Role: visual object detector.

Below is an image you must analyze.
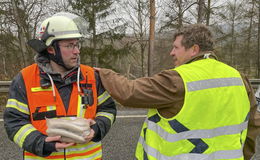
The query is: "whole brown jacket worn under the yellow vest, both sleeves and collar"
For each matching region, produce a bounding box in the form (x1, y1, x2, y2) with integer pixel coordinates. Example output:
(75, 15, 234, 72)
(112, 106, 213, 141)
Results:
(99, 54, 260, 160)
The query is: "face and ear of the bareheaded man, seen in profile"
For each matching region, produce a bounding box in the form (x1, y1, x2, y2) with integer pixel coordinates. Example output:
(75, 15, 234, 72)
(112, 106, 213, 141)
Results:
(170, 35, 193, 67)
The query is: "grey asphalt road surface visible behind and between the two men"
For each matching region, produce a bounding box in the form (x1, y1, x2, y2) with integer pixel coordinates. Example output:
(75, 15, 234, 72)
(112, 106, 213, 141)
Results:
(0, 112, 144, 160)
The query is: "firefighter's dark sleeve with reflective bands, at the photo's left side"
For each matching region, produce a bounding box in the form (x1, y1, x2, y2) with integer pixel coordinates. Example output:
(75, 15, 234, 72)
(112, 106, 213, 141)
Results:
(4, 73, 55, 157)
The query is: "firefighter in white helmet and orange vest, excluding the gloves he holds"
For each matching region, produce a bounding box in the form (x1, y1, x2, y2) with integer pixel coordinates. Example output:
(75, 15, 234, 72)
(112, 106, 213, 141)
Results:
(4, 12, 116, 160)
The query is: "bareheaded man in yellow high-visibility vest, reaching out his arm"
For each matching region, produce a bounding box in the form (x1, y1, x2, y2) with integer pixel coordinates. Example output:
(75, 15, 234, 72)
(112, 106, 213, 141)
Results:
(97, 24, 260, 160)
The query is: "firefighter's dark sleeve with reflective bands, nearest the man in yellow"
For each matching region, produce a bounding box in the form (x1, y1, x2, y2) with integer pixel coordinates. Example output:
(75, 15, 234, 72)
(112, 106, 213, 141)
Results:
(91, 72, 117, 142)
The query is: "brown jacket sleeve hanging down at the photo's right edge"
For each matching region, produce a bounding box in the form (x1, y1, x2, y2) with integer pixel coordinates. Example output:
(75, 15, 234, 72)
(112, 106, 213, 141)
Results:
(241, 74, 260, 160)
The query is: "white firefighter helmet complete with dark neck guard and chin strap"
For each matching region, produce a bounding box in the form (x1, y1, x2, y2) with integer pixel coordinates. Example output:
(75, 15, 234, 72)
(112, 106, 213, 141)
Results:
(27, 12, 87, 69)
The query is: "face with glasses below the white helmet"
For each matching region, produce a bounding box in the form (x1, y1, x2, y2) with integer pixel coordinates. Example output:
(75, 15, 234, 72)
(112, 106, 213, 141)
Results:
(59, 39, 80, 68)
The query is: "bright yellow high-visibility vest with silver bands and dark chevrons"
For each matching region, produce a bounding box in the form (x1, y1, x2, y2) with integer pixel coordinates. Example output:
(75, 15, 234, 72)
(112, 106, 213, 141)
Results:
(136, 59, 250, 160)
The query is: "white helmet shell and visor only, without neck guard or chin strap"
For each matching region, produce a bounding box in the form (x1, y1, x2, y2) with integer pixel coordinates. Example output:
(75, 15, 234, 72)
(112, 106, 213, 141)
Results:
(37, 12, 87, 46)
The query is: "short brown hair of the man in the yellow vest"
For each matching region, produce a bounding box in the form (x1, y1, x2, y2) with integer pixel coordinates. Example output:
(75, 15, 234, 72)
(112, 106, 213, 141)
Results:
(173, 24, 214, 51)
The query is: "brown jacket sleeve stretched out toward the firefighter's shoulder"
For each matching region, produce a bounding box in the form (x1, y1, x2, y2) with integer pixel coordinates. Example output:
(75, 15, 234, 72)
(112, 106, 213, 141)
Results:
(99, 69, 185, 109)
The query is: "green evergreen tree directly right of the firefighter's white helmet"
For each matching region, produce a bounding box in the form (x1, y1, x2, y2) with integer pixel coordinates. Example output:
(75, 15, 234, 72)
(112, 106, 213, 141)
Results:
(69, 0, 129, 69)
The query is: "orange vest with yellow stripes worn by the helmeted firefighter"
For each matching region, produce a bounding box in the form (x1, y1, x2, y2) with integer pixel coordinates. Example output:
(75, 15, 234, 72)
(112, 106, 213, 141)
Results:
(20, 64, 102, 160)
